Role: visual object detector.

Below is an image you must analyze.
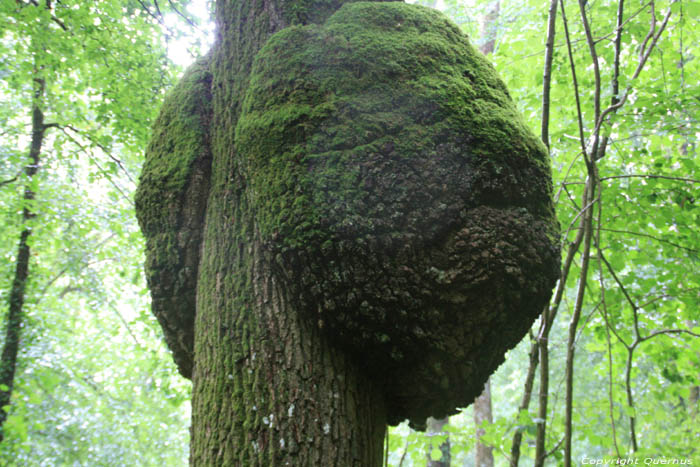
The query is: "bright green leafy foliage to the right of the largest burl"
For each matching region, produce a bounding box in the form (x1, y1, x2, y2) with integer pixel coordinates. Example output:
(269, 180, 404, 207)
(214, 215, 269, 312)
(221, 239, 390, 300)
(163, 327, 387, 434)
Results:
(392, 1, 700, 465)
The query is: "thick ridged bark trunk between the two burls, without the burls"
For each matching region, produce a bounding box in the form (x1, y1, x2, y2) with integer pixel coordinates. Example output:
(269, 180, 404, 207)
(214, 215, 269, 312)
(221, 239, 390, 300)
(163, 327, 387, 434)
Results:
(190, 0, 386, 467)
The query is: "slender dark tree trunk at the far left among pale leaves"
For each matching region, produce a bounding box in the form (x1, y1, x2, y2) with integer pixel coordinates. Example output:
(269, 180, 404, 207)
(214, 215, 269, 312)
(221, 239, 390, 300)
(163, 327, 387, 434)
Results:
(0, 78, 46, 442)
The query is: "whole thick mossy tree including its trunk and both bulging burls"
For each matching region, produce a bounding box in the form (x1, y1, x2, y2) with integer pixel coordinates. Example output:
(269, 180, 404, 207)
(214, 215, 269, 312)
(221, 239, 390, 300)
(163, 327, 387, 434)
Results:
(137, 0, 559, 466)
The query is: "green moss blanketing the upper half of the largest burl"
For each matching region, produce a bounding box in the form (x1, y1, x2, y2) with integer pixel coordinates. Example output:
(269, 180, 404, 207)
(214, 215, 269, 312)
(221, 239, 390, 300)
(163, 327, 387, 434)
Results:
(236, 3, 551, 252)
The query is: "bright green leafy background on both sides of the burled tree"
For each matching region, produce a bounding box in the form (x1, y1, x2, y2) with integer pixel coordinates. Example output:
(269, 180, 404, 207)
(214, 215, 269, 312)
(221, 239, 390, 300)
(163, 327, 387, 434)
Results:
(0, 0, 700, 466)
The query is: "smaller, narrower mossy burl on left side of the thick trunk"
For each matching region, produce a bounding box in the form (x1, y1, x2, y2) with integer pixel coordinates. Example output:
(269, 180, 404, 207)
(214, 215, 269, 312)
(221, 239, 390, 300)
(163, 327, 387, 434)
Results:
(135, 57, 211, 377)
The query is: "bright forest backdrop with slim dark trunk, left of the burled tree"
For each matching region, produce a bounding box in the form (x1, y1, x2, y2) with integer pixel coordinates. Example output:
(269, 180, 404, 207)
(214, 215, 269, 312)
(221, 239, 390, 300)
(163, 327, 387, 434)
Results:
(0, 0, 198, 465)
